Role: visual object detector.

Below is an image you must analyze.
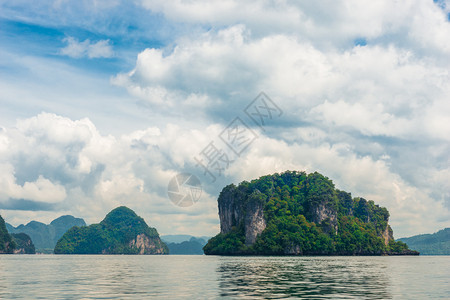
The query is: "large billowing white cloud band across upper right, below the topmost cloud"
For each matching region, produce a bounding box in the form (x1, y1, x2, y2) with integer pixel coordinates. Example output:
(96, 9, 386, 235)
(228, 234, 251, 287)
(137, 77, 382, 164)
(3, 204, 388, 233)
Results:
(113, 25, 450, 139)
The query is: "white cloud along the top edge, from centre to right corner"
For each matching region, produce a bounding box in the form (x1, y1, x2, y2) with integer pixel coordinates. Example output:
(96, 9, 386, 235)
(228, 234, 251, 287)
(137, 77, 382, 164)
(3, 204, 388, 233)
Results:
(141, 0, 450, 53)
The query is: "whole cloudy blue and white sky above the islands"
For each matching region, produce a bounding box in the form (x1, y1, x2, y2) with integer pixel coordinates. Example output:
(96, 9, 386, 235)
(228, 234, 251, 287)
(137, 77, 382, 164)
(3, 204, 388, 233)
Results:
(0, 0, 450, 238)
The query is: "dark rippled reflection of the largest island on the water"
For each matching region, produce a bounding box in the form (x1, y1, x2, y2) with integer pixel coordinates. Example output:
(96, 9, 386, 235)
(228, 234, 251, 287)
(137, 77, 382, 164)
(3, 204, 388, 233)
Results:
(217, 257, 392, 299)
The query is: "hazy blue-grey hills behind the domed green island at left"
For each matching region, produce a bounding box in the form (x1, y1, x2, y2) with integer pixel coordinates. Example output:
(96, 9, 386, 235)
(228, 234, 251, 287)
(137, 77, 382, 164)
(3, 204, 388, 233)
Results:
(6, 215, 86, 253)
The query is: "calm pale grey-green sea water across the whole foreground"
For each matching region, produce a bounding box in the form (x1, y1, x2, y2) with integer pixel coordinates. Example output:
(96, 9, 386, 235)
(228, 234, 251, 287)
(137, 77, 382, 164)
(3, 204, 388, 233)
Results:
(0, 255, 450, 299)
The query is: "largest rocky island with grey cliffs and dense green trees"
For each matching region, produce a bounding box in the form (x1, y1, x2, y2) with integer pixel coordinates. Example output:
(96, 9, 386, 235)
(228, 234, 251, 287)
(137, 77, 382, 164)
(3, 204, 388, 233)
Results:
(203, 171, 419, 255)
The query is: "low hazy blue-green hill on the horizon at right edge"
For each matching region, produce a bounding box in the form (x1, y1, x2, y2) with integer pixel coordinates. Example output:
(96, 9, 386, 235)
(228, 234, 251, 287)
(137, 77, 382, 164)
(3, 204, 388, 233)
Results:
(398, 228, 450, 255)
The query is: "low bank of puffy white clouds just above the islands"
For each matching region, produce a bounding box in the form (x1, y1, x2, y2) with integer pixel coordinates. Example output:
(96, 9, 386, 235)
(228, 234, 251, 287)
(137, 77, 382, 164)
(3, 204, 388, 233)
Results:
(0, 113, 449, 236)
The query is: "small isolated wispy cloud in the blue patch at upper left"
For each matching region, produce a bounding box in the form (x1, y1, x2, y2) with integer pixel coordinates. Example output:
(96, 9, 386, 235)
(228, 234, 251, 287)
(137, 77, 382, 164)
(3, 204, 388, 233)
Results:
(60, 36, 114, 58)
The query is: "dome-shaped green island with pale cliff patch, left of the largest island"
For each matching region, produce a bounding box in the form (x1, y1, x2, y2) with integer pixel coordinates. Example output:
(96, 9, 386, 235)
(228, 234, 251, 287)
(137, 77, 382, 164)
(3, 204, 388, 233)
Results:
(54, 206, 169, 254)
